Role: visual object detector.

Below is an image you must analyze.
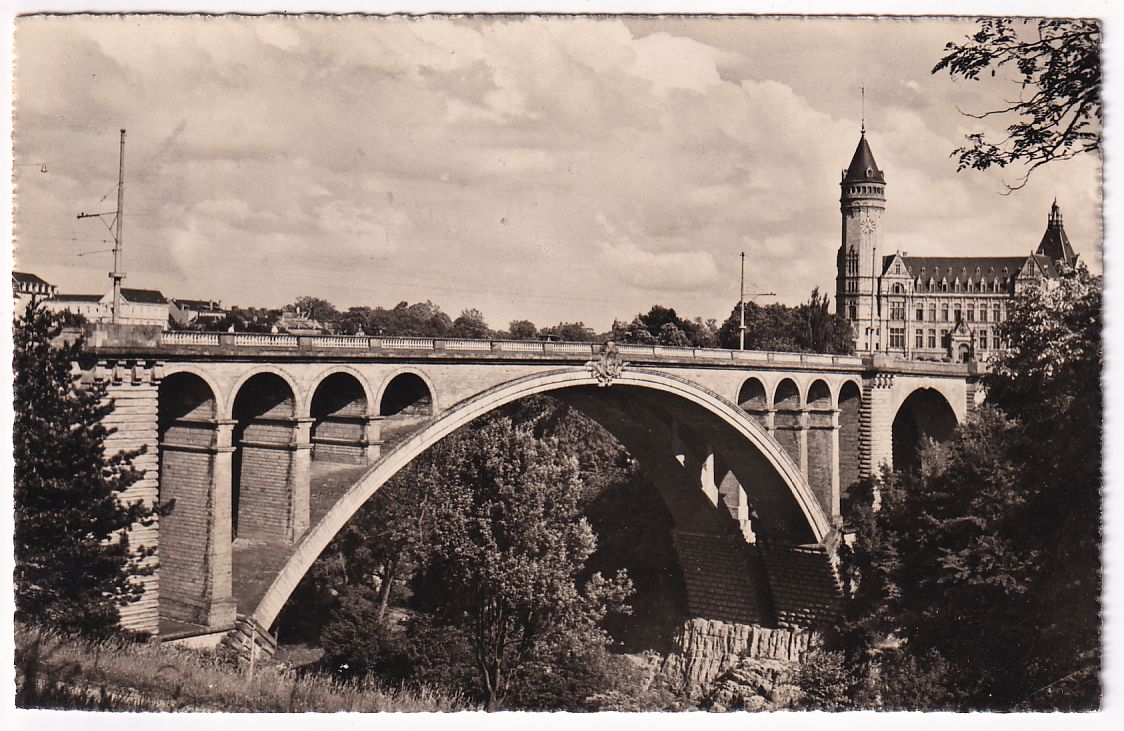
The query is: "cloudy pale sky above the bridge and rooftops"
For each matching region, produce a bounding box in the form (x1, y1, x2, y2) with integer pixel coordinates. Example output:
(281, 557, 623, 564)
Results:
(6, 16, 1102, 331)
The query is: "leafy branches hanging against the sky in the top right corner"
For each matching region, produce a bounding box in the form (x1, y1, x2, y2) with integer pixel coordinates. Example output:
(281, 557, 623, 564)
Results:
(933, 18, 1102, 192)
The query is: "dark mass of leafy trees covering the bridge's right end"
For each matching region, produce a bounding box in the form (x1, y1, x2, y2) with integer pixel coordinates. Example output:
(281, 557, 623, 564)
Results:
(836, 268, 1103, 710)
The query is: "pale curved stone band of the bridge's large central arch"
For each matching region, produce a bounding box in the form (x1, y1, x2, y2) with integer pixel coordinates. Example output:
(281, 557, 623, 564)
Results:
(252, 368, 832, 628)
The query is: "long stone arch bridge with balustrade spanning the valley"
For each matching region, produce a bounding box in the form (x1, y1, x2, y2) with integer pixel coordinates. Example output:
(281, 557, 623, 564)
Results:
(79, 327, 981, 637)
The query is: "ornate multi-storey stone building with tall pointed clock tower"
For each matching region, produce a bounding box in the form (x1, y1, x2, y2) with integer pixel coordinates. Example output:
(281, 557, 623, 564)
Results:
(835, 133, 1077, 361)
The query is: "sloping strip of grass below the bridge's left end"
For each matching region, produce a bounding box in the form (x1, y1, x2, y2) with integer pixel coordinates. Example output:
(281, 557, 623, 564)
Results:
(16, 624, 475, 713)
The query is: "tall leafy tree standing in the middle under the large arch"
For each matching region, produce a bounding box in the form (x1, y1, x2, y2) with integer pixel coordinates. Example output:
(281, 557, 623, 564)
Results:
(428, 421, 631, 709)
